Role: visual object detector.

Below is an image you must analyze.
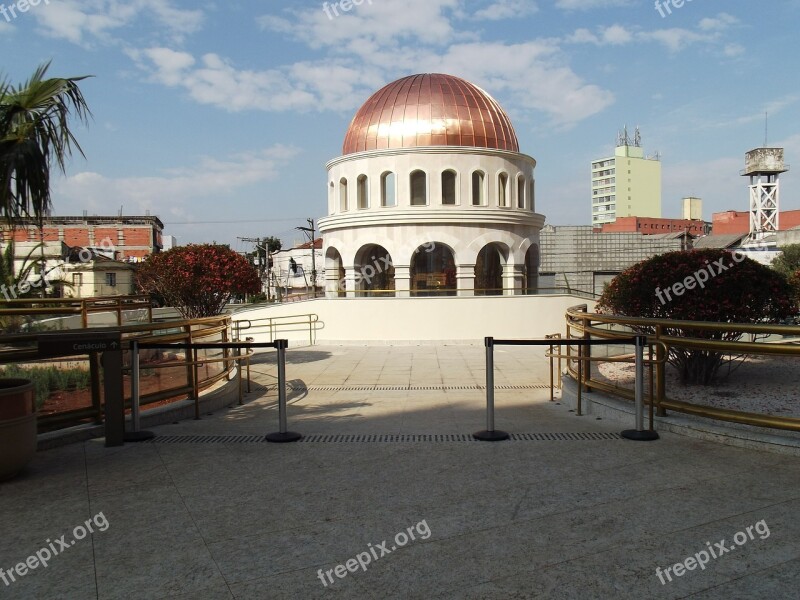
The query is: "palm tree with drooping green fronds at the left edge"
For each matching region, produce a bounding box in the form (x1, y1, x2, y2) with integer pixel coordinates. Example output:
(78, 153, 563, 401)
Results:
(0, 61, 91, 223)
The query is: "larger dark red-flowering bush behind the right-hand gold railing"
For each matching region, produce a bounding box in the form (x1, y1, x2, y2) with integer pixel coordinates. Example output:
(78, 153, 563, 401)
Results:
(597, 249, 797, 385)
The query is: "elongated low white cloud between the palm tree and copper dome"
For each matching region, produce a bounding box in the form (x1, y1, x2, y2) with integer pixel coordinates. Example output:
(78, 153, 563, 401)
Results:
(54, 145, 299, 216)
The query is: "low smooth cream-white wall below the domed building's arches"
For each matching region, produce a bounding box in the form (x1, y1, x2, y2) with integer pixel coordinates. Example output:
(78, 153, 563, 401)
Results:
(233, 295, 594, 344)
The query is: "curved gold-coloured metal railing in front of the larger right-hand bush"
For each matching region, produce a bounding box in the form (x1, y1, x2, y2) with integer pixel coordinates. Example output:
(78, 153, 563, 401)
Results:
(564, 304, 800, 431)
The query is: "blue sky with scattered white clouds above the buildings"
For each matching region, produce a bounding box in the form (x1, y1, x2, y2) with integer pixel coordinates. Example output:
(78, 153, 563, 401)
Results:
(0, 0, 800, 250)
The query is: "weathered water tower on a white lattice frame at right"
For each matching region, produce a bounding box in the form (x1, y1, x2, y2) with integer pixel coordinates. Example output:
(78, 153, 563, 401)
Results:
(741, 148, 789, 243)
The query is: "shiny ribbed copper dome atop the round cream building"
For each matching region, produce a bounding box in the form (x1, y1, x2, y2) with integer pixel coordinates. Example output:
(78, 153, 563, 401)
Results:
(342, 73, 519, 154)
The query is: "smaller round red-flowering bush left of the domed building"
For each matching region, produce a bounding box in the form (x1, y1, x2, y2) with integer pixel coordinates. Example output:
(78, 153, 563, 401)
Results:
(136, 244, 261, 319)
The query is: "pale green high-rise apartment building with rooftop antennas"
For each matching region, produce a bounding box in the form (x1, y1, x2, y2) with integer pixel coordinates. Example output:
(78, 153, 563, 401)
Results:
(592, 127, 661, 225)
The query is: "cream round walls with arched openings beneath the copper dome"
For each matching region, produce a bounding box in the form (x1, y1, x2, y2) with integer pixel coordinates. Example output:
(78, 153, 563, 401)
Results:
(319, 147, 544, 297)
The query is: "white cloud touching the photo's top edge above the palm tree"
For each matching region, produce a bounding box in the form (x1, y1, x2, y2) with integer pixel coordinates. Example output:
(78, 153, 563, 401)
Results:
(31, 0, 203, 45)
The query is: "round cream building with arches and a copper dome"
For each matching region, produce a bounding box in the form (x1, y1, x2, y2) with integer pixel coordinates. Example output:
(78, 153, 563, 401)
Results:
(319, 73, 544, 298)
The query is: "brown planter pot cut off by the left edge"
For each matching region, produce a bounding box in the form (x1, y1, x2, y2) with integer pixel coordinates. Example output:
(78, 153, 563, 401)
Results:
(0, 379, 36, 481)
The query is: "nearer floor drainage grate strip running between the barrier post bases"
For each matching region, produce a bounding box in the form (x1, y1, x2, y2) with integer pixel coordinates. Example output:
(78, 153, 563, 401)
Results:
(146, 431, 622, 444)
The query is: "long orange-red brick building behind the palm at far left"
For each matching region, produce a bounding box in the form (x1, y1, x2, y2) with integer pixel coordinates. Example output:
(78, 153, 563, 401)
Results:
(2, 216, 164, 262)
